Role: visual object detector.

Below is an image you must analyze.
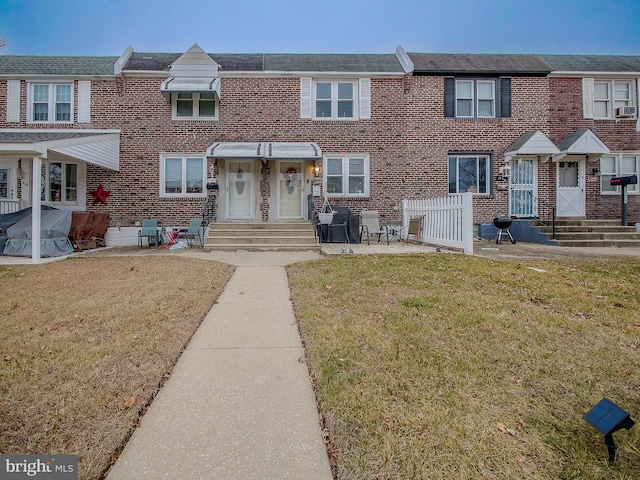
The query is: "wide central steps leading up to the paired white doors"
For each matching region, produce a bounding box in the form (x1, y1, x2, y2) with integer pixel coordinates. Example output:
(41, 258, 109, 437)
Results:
(205, 221, 320, 252)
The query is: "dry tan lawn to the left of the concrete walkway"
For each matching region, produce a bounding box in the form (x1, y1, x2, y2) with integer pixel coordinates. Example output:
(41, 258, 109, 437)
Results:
(0, 256, 233, 479)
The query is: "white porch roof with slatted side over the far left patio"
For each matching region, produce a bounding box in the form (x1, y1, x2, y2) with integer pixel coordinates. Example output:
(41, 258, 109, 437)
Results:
(0, 128, 120, 171)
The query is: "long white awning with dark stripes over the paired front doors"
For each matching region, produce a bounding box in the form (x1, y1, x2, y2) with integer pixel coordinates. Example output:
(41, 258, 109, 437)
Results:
(207, 142, 322, 160)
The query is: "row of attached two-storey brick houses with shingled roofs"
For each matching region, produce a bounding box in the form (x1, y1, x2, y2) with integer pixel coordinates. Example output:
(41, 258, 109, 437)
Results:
(0, 45, 640, 255)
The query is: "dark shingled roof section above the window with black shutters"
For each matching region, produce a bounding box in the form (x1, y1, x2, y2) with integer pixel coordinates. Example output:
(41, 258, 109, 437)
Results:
(408, 53, 551, 76)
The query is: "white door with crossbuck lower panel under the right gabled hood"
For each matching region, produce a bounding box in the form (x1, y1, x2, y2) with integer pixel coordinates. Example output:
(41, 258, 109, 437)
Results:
(556, 159, 585, 217)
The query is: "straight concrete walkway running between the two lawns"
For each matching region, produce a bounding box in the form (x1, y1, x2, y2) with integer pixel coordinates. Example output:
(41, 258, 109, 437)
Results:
(107, 252, 333, 480)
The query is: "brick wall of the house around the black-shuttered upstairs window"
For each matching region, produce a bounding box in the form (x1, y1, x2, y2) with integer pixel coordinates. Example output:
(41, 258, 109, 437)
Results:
(404, 76, 549, 223)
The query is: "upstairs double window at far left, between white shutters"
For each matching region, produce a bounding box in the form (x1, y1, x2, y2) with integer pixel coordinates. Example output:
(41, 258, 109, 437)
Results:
(28, 83, 73, 123)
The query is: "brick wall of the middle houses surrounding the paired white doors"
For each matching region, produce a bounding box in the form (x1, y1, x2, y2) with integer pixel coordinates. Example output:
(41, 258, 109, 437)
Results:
(88, 77, 405, 226)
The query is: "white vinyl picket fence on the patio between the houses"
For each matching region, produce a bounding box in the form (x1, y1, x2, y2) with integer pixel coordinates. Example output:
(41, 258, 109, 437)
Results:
(402, 193, 473, 255)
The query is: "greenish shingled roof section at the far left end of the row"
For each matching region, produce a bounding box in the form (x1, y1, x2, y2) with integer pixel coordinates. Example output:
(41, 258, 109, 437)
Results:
(0, 55, 118, 75)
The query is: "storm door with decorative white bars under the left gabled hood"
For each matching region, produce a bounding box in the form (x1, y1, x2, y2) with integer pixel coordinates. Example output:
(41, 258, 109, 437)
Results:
(509, 158, 538, 218)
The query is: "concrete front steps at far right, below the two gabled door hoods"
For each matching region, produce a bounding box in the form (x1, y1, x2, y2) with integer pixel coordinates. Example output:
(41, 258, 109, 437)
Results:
(538, 218, 640, 248)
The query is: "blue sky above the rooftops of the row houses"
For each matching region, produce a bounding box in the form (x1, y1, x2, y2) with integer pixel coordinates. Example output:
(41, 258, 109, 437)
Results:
(0, 0, 640, 56)
